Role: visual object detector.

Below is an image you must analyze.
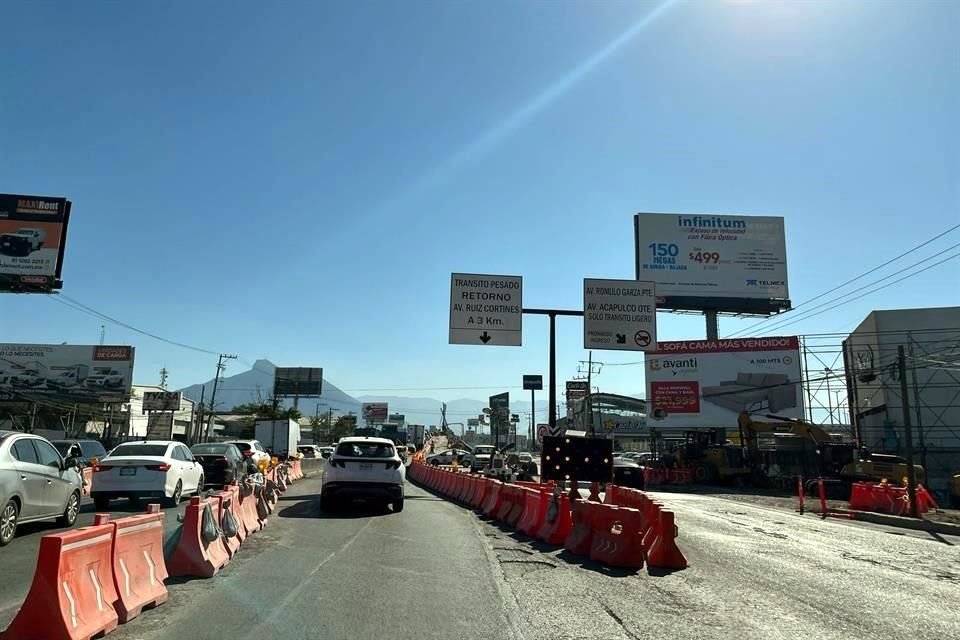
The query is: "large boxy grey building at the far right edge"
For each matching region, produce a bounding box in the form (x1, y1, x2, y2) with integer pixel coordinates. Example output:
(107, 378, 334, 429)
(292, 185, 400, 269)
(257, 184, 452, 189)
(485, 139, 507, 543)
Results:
(843, 307, 960, 491)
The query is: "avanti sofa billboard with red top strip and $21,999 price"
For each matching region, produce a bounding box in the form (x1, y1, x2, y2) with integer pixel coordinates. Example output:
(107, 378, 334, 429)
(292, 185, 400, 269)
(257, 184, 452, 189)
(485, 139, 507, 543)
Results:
(644, 336, 803, 429)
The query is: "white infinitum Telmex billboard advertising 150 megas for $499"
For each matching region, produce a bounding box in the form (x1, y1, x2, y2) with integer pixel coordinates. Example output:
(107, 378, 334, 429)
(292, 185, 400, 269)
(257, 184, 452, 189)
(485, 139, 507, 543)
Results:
(634, 213, 790, 314)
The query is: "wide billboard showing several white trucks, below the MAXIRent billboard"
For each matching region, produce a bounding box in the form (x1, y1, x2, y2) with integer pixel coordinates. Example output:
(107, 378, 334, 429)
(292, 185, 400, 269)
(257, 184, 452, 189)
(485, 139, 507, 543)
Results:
(0, 344, 133, 403)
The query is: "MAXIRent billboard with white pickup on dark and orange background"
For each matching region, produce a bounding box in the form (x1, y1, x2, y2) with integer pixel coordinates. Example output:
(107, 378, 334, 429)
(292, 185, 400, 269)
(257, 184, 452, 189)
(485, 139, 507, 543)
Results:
(0, 193, 71, 293)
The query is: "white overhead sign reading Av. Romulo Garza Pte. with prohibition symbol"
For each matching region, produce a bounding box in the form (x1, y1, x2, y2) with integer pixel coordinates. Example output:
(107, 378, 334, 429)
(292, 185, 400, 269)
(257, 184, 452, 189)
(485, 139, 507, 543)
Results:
(583, 278, 657, 351)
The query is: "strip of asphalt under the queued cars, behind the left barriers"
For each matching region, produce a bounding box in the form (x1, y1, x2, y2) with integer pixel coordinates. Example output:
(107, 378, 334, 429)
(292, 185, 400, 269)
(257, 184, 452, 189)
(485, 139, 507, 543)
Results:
(0, 498, 187, 629)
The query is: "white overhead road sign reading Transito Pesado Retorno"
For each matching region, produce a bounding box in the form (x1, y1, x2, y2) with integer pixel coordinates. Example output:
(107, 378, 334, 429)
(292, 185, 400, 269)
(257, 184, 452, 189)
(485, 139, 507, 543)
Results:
(450, 273, 523, 347)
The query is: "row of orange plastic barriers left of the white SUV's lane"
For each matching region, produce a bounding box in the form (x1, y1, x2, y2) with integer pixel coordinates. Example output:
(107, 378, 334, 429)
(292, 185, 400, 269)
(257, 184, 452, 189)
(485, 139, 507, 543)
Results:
(0, 460, 304, 640)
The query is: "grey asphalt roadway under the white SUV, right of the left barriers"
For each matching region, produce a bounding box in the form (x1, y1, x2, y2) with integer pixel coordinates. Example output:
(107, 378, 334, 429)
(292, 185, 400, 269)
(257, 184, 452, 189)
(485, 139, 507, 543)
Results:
(0, 464, 960, 640)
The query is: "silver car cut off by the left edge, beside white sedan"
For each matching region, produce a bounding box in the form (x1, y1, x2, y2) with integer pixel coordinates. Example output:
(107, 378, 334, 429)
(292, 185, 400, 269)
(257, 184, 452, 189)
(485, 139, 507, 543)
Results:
(0, 431, 82, 547)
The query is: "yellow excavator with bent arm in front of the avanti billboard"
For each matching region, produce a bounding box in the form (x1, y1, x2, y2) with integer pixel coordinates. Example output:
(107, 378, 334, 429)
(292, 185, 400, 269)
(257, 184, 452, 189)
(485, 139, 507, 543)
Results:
(737, 412, 926, 485)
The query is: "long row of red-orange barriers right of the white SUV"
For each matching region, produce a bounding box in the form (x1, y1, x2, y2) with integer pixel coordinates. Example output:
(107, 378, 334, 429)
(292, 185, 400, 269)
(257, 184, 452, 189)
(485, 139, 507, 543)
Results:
(407, 462, 687, 569)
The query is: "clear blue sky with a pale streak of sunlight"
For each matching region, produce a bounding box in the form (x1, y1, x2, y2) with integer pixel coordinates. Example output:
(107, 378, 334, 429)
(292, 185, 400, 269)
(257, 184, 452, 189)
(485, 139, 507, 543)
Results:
(0, 1, 960, 416)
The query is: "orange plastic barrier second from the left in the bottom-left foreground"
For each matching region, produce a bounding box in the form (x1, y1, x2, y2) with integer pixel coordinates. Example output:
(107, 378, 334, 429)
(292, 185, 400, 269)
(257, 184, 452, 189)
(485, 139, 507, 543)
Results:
(110, 504, 167, 622)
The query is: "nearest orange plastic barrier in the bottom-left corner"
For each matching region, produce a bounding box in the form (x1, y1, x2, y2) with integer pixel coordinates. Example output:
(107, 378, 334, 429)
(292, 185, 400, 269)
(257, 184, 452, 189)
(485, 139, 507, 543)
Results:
(0, 515, 119, 640)
